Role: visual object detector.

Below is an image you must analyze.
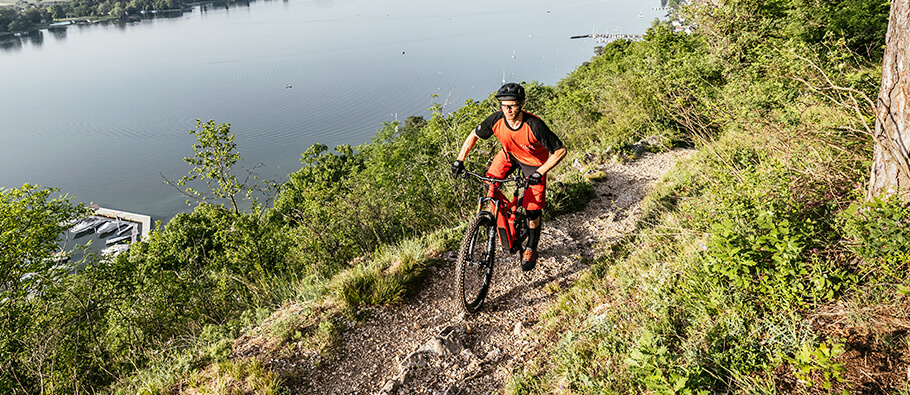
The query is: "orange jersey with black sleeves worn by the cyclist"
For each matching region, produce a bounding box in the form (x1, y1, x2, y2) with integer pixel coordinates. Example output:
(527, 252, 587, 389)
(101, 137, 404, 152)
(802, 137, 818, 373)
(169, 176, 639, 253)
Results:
(474, 111, 562, 167)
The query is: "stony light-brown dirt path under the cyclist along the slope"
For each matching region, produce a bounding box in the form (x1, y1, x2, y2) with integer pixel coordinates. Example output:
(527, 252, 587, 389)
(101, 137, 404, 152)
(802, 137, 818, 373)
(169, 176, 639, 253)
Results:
(290, 150, 693, 395)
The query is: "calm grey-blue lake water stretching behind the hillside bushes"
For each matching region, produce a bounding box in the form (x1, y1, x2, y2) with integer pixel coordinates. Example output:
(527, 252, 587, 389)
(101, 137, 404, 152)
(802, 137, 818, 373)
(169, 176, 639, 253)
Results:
(0, 0, 664, 221)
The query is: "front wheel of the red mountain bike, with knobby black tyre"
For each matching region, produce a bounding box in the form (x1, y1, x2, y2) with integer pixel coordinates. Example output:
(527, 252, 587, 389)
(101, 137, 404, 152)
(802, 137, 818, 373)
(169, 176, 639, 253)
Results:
(455, 213, 496, 314)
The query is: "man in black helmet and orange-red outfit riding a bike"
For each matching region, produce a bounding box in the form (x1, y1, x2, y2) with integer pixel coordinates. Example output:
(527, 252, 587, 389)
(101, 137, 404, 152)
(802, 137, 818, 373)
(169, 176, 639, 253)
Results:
(452, 82, 566, 271)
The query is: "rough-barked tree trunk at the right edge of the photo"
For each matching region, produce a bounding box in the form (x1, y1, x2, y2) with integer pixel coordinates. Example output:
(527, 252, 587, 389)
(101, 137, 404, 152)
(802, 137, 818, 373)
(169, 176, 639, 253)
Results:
(866, 0, 910, 202)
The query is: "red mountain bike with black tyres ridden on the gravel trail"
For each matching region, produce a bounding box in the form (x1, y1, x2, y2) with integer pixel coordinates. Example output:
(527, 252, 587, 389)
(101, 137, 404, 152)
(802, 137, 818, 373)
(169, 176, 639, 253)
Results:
(455, 171, 528, 314)
